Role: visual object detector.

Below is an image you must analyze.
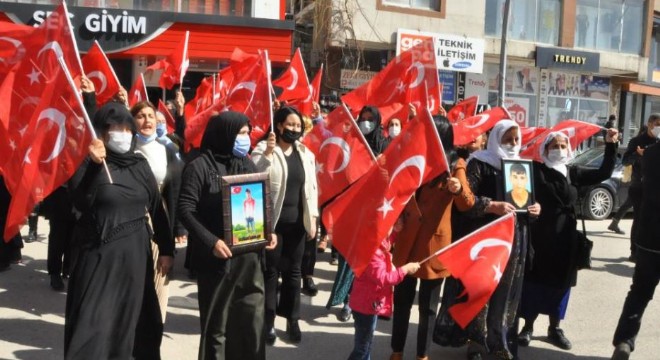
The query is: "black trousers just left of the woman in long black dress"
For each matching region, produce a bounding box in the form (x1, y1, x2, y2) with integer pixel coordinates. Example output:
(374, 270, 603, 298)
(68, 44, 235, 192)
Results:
(48, 219, 76, 275)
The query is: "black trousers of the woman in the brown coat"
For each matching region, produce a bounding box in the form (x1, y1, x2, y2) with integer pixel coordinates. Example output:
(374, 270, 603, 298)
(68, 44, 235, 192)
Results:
(391, 276, 444, 357)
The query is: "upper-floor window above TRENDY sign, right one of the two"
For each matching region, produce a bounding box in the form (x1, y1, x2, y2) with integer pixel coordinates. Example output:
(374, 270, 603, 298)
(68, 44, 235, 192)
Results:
(575, 0, 644, 54)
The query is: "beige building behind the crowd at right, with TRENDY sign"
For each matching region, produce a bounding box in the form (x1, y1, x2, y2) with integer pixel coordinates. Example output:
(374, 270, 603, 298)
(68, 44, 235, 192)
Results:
(314, 0, 660, 145)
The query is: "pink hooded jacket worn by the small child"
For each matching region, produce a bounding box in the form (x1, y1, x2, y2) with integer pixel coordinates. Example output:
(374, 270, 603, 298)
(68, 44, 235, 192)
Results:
(349, 240, 406, 317)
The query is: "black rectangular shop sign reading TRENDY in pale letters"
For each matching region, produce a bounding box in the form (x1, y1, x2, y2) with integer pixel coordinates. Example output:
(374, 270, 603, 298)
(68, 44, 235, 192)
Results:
(536, 47, 600, 72)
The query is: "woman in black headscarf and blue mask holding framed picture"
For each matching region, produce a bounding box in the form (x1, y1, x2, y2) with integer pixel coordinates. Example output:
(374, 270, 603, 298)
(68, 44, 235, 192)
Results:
(178, 111, 277, 360)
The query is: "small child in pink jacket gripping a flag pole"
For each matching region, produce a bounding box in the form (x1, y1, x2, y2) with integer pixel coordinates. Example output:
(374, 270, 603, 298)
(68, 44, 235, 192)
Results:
(348, 238, 419, 360)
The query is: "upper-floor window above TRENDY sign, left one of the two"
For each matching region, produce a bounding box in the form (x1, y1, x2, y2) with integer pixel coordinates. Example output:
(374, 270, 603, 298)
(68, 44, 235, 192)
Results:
(485, 0, 561, 45)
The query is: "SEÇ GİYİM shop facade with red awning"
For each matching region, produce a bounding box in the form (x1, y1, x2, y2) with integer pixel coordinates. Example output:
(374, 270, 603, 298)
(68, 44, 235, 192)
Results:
(0, 0, 294, 98)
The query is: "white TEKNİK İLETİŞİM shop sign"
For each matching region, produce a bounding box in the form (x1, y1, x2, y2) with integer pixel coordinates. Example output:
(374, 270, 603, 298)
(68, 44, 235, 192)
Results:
(396, 29, 485, 73)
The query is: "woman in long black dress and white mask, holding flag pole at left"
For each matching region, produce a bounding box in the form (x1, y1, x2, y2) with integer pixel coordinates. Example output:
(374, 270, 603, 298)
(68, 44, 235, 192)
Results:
(64, 102, 174, 359)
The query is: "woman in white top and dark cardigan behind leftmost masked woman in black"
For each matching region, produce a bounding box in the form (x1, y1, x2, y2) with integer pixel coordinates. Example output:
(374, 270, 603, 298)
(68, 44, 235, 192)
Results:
(131, 101, 188, 322)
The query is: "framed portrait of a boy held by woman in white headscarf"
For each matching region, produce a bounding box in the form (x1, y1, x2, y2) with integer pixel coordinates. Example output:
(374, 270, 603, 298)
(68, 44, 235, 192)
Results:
(502, 159, 534, 212)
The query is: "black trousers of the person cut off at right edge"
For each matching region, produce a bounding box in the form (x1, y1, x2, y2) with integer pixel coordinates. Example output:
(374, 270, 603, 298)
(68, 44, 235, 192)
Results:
(612, 249, 660, 350)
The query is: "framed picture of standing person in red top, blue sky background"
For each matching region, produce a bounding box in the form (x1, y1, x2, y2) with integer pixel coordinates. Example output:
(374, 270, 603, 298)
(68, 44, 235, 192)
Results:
(222, 173, 272, 254)
